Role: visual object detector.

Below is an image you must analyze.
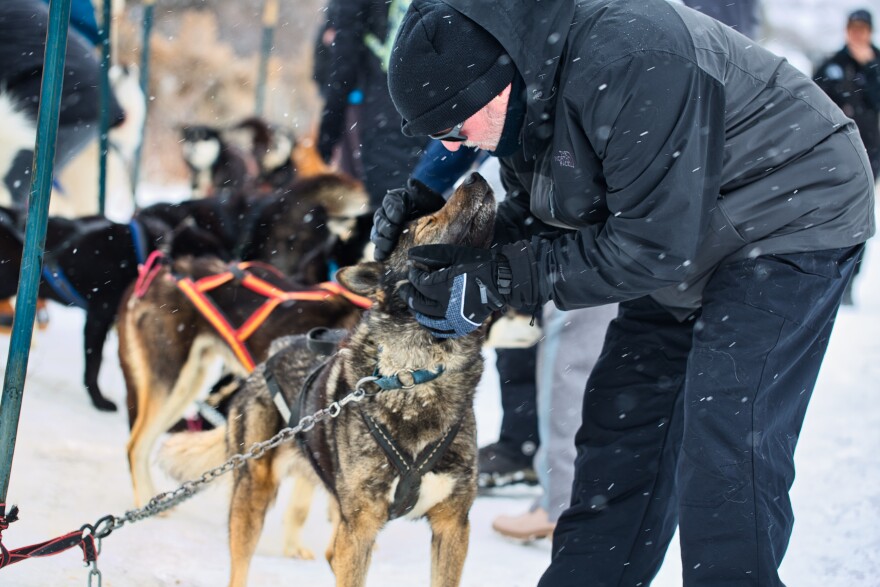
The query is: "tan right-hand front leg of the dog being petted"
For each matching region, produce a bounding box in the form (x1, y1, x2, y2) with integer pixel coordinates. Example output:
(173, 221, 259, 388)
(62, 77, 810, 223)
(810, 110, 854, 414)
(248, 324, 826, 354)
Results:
(428, 501, 470, 587)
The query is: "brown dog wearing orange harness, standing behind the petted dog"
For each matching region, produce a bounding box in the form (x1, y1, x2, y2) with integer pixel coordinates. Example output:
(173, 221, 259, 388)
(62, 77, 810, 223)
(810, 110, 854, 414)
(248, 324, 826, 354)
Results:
(118, 258, 362, 505)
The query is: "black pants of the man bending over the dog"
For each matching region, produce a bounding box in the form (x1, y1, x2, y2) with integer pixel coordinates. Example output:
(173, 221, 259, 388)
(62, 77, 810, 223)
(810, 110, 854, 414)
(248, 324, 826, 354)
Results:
(540, 246, 863, 587)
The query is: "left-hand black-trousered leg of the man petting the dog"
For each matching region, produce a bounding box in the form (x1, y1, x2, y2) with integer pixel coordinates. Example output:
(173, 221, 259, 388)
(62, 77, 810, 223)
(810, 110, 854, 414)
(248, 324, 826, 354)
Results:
(539, 297, 694, 587)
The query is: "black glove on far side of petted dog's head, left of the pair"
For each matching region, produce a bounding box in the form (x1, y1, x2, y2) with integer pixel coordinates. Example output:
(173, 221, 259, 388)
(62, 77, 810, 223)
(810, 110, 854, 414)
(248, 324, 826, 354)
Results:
(370, 179, 446, 261)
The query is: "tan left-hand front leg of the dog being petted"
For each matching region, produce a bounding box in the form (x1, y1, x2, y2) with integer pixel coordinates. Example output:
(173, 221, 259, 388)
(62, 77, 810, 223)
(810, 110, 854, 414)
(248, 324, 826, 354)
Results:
(330, 504, 388, 587)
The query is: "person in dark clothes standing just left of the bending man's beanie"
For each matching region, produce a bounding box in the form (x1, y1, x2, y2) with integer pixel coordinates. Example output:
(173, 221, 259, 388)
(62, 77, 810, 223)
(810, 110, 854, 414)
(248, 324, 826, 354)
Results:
(318, 0, 427, 209)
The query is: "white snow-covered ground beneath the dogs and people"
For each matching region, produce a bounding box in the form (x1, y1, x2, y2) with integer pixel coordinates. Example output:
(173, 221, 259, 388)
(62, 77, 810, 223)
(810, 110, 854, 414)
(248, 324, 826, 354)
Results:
(0, 209, 880, 587)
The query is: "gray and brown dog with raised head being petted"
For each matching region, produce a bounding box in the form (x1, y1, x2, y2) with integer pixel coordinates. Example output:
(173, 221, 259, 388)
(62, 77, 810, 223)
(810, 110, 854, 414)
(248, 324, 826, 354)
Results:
(160, 174, 495, 587)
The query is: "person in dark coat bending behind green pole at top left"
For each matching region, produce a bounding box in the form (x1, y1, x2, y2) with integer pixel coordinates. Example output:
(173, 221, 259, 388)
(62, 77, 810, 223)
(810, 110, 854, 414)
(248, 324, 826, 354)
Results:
(0, 0, 125, 206)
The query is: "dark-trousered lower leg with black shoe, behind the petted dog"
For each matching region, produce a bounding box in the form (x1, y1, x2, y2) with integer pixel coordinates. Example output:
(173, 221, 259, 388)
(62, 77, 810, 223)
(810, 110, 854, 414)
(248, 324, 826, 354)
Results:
(477, 345, 540, 488)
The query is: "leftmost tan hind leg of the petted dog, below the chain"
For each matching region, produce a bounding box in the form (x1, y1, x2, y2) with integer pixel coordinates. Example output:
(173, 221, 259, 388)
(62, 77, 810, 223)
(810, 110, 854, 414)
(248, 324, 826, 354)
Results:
(229, 454, 278, 587)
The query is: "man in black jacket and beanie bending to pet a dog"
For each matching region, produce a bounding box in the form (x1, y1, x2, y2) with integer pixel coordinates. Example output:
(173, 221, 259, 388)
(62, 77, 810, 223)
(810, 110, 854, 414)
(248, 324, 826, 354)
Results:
(373, 0, 874, 587)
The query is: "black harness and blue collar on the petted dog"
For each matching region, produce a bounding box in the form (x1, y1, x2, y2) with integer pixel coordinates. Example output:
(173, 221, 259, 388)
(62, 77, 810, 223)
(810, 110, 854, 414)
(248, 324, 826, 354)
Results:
(264, 338, 461, 520)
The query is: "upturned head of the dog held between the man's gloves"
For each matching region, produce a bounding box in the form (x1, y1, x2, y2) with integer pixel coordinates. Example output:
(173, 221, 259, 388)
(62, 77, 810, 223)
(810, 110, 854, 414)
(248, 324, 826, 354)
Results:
(336, 173, 495, 309)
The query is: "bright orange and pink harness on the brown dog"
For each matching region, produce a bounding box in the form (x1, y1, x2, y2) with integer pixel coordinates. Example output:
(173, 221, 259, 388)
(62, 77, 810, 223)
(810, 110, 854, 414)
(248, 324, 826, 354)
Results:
(134, 251, 372, 372)
